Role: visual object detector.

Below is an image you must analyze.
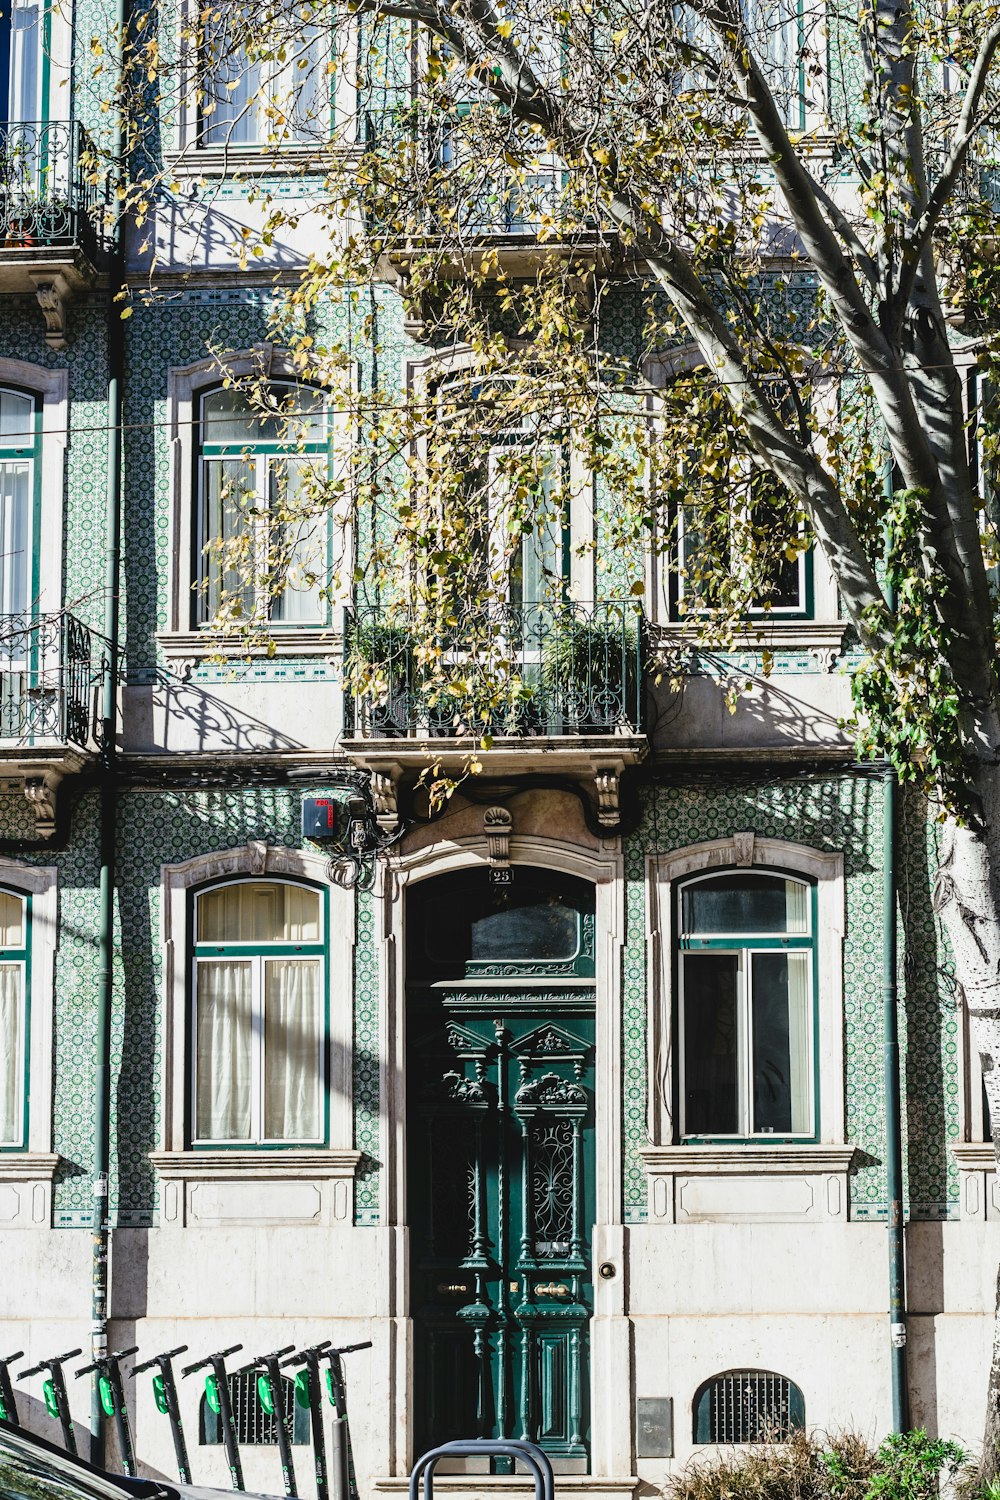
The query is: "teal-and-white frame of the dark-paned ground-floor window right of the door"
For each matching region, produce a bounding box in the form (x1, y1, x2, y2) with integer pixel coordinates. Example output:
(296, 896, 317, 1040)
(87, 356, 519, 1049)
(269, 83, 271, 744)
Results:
(673, 867, 820, 1146)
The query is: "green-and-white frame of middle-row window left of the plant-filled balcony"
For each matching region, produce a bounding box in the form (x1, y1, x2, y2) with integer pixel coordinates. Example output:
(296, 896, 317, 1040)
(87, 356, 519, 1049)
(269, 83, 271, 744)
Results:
(192, 380, 333, 635)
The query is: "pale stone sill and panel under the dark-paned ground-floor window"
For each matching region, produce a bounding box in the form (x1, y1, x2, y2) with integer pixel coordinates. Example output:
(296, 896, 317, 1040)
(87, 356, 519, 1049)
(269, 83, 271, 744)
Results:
(639, 1145, 855, 1224)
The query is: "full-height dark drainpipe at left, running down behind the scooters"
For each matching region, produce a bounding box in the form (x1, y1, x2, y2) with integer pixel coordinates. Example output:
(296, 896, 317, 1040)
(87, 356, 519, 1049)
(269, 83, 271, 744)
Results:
(90, 0, 127, 1469)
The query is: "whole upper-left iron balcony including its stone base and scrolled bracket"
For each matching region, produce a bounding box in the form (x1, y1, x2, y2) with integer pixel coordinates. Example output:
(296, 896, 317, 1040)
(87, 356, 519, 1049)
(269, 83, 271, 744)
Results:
(0, 120, 103, 350)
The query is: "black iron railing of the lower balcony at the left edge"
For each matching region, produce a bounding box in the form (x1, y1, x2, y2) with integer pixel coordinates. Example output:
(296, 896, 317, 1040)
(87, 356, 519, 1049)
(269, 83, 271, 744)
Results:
(0, 615, 100, 750)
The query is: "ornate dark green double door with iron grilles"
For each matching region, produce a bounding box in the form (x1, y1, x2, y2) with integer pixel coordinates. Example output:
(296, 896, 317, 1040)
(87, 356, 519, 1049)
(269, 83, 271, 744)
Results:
(406, 984, 594, 1470)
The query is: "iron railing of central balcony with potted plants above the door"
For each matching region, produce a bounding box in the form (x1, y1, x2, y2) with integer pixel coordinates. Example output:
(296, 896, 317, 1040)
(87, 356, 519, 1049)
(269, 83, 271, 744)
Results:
(343, 600, 645, 740)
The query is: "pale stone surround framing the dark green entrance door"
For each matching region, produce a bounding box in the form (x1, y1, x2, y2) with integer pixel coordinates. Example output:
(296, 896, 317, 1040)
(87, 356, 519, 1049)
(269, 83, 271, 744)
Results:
(375, 834, 630, 1475)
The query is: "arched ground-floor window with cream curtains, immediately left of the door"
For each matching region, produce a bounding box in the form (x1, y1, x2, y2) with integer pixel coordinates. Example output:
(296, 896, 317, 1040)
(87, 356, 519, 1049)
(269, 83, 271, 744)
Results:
(190, 881, 327, 1146)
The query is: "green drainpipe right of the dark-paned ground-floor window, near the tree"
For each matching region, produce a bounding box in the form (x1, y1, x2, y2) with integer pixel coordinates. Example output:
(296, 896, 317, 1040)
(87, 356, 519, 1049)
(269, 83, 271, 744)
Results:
(882, 462, 910, 1433)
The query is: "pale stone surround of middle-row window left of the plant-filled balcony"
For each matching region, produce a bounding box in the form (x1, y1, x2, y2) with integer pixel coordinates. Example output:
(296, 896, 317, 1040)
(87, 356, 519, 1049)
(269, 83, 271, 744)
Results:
(165, 344, 357, 633)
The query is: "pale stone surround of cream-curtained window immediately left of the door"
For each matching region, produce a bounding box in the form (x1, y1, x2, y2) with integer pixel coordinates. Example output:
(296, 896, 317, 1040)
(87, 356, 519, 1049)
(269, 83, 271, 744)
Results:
(159, 843, 354, 1155)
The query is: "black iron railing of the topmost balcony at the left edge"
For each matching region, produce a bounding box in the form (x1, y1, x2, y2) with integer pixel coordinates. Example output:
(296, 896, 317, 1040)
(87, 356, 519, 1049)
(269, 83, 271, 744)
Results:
(0, 120, 102, 257)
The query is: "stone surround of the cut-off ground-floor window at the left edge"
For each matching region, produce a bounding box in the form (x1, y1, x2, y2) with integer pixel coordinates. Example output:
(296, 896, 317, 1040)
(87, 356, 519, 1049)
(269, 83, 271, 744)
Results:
(0, 858, 58, 1158)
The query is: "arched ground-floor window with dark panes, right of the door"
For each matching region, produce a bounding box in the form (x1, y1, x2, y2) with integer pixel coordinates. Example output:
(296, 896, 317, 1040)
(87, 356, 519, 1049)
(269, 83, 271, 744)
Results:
(678, 870, 817, 1140)
